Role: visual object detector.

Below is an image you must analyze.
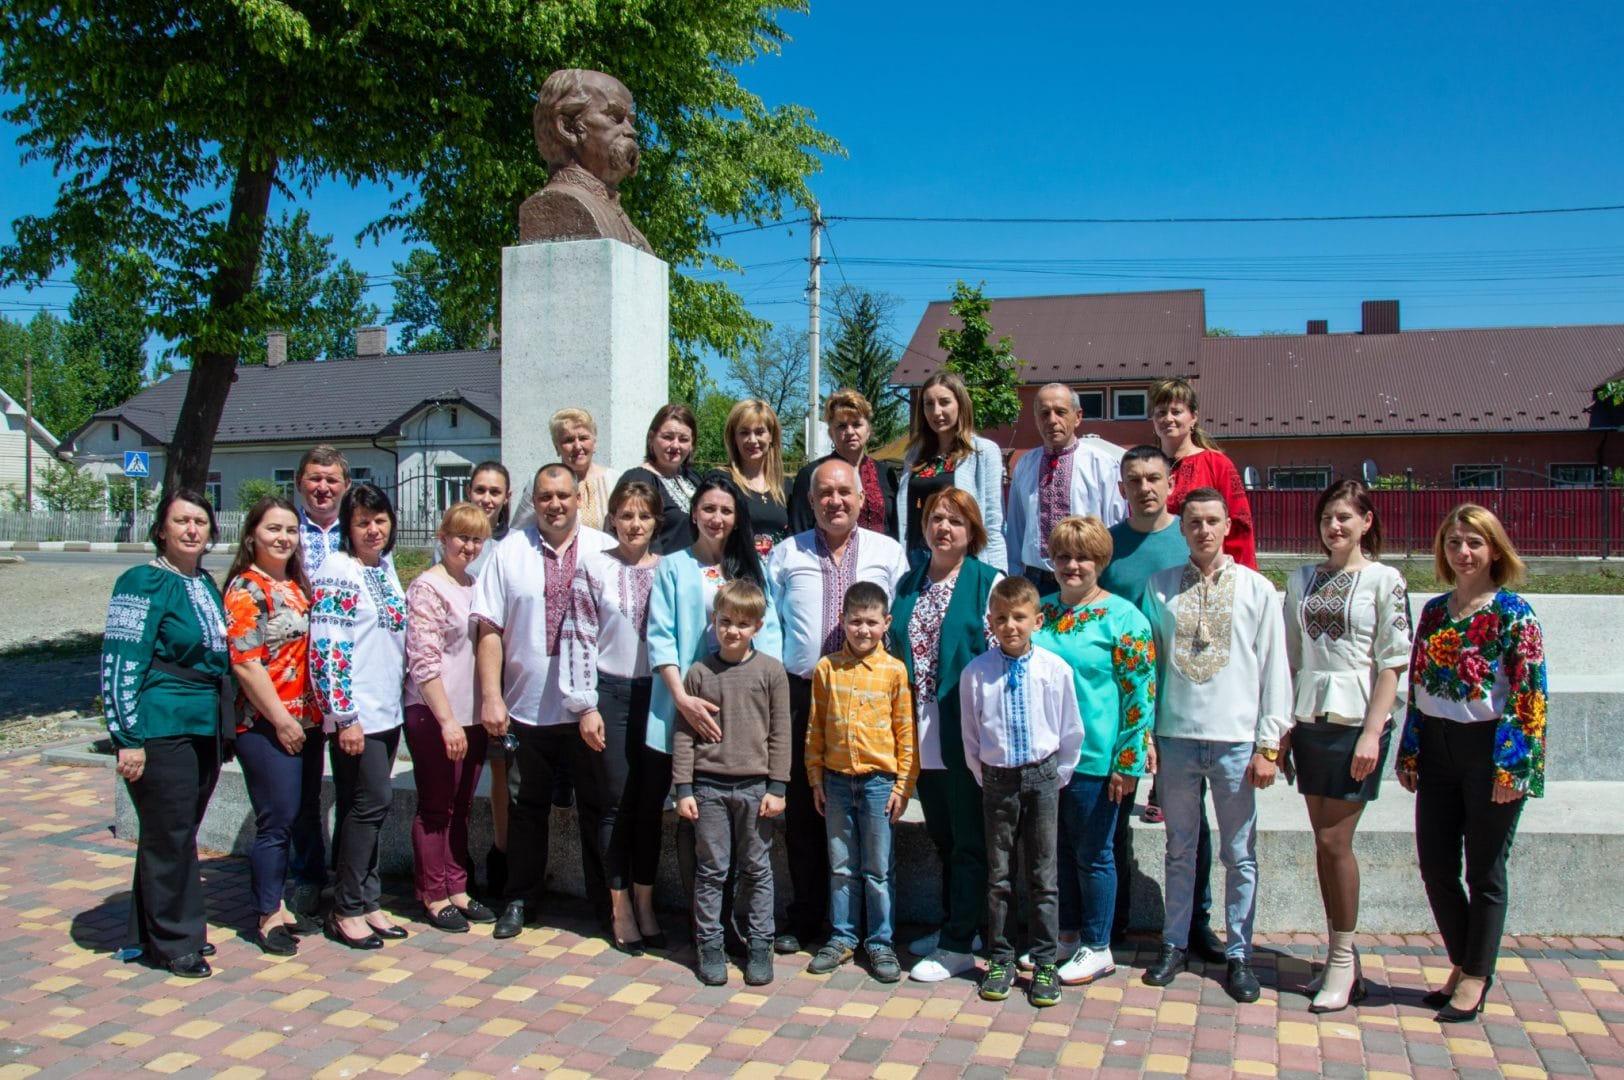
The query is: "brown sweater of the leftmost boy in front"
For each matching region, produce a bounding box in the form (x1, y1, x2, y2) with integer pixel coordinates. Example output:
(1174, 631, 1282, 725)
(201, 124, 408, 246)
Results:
(671, 651, 789, 799)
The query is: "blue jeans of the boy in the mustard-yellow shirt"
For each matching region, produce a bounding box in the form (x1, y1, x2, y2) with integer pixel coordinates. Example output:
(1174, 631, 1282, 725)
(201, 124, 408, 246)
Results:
(823, 773, 896, 948)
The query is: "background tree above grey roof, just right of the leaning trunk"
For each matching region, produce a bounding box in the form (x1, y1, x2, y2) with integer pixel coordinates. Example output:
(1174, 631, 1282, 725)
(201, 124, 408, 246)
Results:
(242, 210, 380, 364)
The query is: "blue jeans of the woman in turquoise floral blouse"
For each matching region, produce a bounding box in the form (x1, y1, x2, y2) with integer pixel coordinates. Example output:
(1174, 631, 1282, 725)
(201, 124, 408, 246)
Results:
(1057, 773, 1121, 948)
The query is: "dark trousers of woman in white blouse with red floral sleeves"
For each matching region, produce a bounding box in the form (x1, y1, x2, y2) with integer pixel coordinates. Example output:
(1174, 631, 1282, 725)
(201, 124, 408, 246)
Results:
(331, 728, 401, 919)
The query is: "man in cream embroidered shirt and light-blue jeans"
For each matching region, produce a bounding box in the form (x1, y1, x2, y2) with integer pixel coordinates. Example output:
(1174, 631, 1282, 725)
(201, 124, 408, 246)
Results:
(1143, 487, 1291, 1002)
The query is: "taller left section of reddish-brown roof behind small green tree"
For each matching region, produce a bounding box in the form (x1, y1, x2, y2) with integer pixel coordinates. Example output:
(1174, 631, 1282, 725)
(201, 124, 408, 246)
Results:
(892, 289, 1207, 387)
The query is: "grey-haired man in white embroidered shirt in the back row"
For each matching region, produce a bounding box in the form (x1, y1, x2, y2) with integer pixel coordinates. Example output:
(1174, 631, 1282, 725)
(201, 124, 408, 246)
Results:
(1004, 383, 1127, 596)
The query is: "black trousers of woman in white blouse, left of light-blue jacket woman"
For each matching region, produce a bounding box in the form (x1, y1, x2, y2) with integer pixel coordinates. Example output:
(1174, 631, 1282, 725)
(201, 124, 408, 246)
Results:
(588, 674, 671, 888)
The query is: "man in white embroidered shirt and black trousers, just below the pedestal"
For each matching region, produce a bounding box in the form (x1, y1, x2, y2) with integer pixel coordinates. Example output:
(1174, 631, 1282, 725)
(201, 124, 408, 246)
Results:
(473, 464, 614, 937)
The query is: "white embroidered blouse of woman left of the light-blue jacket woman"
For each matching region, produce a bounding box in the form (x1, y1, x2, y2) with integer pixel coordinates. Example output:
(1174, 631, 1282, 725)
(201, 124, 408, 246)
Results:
(559, 551, 659, 716)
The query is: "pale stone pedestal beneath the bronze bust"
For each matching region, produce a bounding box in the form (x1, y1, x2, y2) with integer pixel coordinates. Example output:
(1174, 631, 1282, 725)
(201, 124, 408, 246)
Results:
(502, 240, 671, 492)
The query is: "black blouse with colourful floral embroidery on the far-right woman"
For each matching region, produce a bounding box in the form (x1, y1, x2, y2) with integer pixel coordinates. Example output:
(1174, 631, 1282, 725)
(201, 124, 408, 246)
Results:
(1398, 590, 1546, 797)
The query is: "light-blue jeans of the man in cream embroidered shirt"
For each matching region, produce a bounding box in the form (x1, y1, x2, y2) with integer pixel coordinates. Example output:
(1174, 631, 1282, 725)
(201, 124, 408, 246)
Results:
(1156, 739, 1257, 960)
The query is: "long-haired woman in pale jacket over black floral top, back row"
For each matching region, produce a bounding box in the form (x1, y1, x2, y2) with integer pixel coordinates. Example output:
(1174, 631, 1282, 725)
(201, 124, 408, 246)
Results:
(896, 372, 1009, 567)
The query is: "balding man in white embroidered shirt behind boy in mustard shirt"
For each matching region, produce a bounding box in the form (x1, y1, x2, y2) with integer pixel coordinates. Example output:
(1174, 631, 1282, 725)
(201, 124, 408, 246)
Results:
(767, 458, 908, 953)
